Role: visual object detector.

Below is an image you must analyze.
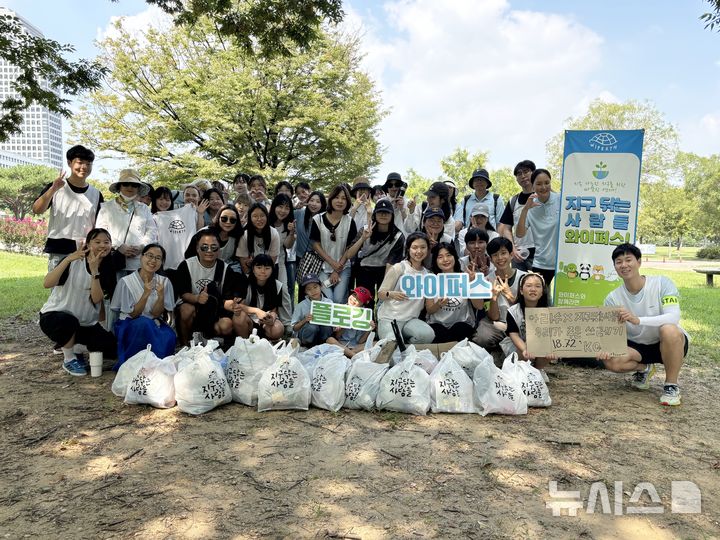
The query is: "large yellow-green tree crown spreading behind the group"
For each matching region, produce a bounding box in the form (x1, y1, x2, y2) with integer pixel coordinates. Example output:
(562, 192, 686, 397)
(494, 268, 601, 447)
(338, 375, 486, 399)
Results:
(73, 19, 385, 192)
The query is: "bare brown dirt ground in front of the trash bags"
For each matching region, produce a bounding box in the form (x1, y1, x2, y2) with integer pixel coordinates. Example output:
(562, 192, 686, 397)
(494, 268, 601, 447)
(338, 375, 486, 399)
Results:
(0, 321, 720, 539)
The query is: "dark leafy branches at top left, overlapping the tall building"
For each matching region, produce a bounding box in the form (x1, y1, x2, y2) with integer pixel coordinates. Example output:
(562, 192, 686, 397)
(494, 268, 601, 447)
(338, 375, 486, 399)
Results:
(0, 15, 105, 142)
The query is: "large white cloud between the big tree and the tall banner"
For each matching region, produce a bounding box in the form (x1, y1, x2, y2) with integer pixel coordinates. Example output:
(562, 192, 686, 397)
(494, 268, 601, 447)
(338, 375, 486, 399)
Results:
(345, 0, 604, 176)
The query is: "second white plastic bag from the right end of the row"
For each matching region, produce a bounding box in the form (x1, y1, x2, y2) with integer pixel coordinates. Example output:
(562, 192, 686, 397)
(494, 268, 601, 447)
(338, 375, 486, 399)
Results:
(473, 358, 527, 416)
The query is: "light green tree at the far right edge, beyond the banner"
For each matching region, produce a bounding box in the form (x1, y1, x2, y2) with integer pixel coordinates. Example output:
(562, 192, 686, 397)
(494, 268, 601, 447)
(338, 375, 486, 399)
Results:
(678, 152, 720, 240)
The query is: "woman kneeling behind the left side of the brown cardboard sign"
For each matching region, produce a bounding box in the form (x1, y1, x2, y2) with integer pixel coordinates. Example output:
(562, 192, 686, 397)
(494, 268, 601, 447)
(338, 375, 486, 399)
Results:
(500, 272, 557, 382)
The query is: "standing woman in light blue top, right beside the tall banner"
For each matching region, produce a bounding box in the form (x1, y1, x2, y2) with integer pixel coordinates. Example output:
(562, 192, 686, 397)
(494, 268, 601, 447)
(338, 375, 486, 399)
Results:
(516, 169, 560, 285)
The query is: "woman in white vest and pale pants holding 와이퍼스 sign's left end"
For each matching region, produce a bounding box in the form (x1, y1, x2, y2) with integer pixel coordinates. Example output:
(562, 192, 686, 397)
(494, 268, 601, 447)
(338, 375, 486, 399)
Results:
(377, 232, 435, 343)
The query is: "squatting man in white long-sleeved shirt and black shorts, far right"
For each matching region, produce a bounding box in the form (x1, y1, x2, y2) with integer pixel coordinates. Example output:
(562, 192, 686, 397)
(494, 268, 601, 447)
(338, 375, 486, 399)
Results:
(597, 244, 690, 405)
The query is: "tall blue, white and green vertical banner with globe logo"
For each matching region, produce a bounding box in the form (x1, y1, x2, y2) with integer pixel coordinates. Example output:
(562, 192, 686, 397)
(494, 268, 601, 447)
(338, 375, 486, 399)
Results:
(553, 129, 645, 306)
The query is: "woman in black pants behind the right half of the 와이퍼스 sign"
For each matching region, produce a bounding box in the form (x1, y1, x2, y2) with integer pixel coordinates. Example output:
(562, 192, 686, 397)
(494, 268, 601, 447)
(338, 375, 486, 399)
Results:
(425, 242, 485, 343)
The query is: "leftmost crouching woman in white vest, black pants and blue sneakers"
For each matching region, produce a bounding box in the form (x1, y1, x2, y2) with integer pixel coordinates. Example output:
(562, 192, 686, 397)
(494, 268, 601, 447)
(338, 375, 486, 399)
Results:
(40, 229, 117, 377)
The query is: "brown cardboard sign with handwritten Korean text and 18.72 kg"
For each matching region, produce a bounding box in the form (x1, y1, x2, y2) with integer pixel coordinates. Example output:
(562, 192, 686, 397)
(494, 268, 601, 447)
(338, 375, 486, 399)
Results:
(525, 307, 627, 358)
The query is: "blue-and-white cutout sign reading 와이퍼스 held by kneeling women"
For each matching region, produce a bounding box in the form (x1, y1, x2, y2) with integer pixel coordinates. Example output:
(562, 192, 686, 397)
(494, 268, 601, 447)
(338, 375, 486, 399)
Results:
(400, 272, 492, 299)
